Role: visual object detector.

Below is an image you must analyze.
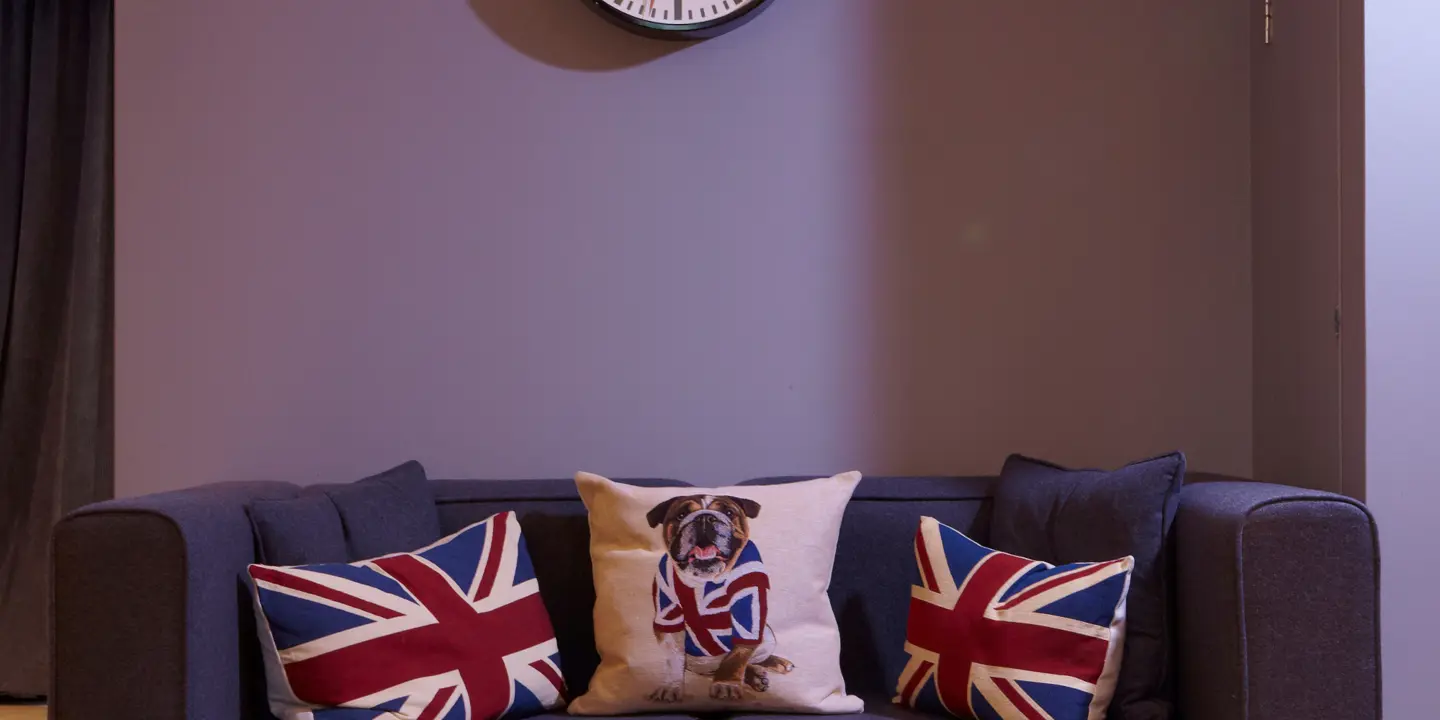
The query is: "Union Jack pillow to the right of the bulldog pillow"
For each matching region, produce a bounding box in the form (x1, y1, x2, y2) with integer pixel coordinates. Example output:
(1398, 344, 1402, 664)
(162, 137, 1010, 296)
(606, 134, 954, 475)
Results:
(894, 517, 1135, 720)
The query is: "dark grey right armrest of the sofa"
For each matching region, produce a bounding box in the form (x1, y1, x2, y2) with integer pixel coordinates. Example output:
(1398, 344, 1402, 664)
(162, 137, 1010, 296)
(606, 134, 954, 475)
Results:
(1175, 482, 1380, 720)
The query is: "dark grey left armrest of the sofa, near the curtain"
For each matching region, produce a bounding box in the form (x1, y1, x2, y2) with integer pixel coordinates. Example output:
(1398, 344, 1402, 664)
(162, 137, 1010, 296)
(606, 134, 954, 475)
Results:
(50, 482, 297, 720)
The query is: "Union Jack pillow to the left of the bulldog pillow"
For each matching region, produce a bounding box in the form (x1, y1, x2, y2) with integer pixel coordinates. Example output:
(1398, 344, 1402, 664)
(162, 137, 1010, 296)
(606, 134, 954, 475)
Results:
(249, 513, 564, 720)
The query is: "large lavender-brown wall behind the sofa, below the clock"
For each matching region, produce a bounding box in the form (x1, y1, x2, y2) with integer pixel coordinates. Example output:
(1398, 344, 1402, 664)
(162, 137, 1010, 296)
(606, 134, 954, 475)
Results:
(117, 0, 1251, 495)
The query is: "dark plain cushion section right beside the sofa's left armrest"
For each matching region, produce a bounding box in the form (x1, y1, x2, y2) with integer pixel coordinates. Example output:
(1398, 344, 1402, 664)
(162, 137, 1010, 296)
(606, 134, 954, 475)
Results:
(248, 491, 350, 564)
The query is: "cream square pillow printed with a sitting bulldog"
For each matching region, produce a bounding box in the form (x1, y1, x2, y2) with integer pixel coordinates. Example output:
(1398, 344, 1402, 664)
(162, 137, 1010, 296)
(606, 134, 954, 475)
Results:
(570, 472, 864, 714)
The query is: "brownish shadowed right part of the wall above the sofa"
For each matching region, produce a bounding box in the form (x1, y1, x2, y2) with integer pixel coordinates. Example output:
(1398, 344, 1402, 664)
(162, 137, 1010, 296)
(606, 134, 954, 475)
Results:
(865, 0, 1250, 474)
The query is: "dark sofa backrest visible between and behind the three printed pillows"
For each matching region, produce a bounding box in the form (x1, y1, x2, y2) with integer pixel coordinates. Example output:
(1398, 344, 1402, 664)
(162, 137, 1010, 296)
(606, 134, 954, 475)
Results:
(433, 477, 994, 698)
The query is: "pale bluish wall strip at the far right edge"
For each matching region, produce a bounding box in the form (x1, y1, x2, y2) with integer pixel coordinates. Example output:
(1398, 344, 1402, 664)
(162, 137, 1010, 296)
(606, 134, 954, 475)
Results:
(1365, 0, 1440, 719)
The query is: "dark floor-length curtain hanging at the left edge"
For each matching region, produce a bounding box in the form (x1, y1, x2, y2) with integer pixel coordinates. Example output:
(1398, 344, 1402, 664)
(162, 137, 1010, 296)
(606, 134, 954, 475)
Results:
(0, 0, 114, 697)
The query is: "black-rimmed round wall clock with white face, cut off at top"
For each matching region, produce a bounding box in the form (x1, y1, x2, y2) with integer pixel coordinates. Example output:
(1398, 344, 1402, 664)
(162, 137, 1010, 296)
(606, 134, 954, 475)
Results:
(584, 0, 775, 40)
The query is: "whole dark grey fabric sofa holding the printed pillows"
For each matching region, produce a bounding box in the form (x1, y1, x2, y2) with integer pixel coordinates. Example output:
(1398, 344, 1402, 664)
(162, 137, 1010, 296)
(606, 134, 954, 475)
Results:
(50, 478, 1380, 720)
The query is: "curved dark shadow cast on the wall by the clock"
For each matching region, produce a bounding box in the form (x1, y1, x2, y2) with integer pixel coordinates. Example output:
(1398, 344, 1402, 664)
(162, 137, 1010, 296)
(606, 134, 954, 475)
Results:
(469, 0, 691, 72)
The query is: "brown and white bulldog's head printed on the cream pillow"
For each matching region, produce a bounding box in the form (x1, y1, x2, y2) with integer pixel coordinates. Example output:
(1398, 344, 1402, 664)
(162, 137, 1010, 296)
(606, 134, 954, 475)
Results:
(645, 495, 760, 580)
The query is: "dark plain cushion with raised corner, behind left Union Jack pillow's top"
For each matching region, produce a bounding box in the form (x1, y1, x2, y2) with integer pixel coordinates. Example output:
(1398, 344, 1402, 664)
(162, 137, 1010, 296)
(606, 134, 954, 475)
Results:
(325, 461, 441, 560)
